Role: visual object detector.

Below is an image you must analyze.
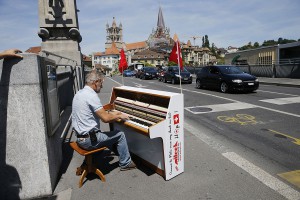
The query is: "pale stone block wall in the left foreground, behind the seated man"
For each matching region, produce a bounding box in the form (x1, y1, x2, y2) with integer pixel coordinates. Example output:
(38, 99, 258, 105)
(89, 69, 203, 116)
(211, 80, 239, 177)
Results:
(0, 54, 63, 199)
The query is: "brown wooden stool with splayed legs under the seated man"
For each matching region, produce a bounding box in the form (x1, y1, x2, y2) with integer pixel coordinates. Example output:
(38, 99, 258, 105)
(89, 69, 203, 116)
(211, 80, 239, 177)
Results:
(70, 142, 106, 188)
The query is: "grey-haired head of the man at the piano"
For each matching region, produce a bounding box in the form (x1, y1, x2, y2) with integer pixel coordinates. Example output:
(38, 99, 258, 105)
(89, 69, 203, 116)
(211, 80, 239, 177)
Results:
(85, 70, 104, 93)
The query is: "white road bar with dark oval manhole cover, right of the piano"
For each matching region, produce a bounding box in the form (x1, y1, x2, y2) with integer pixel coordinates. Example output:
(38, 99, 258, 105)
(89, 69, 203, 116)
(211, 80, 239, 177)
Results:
(185, 102, 256, 114)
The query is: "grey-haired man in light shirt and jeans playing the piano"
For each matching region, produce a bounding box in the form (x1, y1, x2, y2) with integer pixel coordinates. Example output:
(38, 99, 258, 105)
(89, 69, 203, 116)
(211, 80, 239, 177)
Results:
(72, 70, 136, 171)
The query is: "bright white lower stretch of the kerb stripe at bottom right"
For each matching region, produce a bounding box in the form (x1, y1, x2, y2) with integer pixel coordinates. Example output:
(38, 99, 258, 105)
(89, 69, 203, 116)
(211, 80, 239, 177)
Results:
(222, 152, 300, 200)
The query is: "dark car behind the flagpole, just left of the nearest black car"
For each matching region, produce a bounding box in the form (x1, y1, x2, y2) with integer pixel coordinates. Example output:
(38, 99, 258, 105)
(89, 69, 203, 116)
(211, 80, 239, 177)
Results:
(163, 66, 193, 84)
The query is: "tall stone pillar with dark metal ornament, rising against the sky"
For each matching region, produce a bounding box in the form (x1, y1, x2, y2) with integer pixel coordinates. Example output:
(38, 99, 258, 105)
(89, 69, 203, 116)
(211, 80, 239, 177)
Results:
(38, 0, 82, 65)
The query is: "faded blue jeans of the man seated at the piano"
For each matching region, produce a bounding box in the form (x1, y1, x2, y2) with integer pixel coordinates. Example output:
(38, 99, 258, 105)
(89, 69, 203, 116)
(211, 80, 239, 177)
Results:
(77, 130, 131, 167)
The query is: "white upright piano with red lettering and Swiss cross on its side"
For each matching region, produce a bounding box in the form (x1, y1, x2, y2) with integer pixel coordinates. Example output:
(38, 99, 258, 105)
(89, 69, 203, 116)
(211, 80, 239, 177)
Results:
(104, 86, 184, 180)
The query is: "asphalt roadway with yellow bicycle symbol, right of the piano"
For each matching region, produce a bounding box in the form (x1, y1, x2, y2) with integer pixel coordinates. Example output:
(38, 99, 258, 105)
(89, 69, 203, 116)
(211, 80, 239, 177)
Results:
(109, 76, 300, 196)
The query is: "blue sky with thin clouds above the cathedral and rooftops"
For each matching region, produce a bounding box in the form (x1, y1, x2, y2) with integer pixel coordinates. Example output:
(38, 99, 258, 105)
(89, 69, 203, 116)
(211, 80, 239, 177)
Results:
(0, 0, 300, 55)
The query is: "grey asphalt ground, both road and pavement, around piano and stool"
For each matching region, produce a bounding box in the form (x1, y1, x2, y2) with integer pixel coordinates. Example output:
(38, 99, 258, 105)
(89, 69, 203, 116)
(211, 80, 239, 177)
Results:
(53, 76, 300, 200)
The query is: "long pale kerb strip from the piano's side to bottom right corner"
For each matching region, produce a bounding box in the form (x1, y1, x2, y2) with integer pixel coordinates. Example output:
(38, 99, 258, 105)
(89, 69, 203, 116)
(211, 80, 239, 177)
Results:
(184, 122, 300, 200)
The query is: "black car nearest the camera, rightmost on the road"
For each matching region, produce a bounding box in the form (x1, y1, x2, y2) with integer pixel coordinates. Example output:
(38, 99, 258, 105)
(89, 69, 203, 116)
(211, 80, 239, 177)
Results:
(196, 65, 259, 93)
